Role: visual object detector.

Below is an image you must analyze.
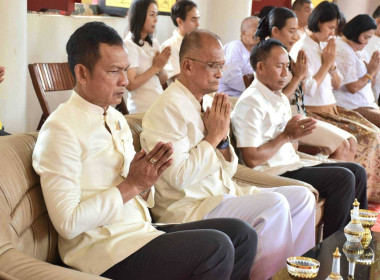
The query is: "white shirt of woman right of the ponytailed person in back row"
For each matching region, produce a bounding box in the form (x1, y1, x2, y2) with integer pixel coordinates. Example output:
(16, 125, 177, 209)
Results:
(289, 33, 336, 106)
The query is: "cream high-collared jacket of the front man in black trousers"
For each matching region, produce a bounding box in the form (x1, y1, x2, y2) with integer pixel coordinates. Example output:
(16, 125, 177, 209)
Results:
(33, 91, 163, 275)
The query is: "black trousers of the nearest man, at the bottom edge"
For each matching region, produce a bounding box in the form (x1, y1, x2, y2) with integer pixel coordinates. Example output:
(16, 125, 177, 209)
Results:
(101, 218, 257, 280)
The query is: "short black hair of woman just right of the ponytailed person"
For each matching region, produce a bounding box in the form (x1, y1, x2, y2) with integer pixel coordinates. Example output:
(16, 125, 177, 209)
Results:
(307, 1, 341, 33)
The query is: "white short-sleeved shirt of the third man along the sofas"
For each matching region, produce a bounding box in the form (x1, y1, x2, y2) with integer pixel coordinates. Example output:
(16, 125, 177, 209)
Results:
(231, 79, 320, 174)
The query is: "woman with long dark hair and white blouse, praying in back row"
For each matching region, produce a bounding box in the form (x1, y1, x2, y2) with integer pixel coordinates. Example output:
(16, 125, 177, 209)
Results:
(124, 0, 171, 114)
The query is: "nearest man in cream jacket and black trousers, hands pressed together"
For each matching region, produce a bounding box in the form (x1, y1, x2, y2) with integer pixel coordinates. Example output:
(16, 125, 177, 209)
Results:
(33, 22, 257, 280)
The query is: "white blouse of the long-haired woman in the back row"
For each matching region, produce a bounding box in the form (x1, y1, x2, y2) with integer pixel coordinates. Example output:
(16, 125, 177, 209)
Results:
(124, 32, 163, 114)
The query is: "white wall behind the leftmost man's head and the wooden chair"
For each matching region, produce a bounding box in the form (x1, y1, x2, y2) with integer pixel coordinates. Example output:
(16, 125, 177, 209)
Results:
(26, 13, 174, 131)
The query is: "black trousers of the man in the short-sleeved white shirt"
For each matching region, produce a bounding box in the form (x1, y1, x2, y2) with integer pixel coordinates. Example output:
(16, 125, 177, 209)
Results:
(281, 162, 368, 238)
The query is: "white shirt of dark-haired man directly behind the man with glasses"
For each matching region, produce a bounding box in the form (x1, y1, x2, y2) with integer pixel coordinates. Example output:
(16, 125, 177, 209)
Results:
(161, 28, 183, 79)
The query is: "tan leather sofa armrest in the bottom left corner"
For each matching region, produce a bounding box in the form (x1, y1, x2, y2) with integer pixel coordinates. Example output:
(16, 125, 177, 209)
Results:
(0, 249, 107, 280)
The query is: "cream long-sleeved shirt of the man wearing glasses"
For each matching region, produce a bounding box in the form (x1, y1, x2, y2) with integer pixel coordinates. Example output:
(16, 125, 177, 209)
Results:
(140, 80, 258, 223)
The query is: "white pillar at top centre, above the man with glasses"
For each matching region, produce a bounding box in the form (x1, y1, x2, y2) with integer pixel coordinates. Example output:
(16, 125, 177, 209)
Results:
(193, 0, 252, 44)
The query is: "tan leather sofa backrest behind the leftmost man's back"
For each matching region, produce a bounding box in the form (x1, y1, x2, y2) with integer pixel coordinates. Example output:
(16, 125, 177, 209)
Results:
(0, 133, 59, 263)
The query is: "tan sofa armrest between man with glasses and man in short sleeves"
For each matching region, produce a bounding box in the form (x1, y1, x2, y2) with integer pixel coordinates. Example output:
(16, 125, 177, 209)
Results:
(233, 164, 319, 201)
